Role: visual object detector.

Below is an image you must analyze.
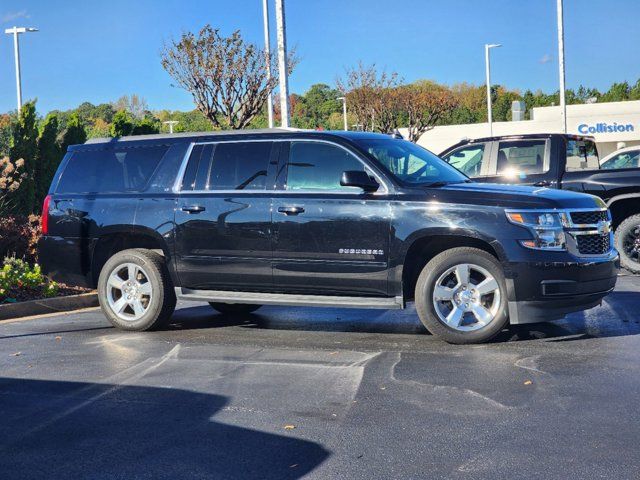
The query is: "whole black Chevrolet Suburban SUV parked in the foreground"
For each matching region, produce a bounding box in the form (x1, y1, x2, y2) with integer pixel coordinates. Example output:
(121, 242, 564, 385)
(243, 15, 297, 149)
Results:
(39, 129, 619, 343)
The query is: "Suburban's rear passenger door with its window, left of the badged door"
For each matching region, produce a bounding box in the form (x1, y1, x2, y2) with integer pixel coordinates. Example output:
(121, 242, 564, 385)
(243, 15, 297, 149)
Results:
(175, 141, 277, 290)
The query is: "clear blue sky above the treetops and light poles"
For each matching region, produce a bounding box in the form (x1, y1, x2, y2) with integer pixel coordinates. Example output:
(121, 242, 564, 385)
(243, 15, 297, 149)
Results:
(0, 0, 640, 113)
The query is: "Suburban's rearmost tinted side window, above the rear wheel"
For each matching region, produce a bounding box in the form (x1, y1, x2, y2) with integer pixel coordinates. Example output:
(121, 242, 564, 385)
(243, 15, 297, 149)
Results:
(56, 145, 169, 193)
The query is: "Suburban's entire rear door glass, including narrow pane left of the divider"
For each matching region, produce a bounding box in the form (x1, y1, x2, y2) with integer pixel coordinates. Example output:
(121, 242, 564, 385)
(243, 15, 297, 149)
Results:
(182, 142, 273, 191)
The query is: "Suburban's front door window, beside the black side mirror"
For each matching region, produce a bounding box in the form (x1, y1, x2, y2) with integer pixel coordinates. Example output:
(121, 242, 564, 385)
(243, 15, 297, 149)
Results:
(287, 142, 365, 191)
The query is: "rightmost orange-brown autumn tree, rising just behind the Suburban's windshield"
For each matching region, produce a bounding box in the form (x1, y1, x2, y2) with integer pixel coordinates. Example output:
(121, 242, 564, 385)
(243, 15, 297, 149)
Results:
(398, 80, 457, 143)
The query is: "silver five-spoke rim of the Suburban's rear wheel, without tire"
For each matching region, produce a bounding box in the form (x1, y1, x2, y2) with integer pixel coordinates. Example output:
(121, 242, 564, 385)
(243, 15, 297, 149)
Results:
(105, 263, 153, 322)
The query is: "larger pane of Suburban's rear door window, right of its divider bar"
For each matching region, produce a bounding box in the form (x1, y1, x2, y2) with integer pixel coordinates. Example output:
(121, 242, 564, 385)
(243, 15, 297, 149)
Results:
(205, 142, 273, 190)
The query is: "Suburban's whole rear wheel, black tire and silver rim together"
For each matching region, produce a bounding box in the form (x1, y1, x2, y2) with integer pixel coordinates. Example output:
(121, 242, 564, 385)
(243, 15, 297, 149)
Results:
(98, 249, 176, 331)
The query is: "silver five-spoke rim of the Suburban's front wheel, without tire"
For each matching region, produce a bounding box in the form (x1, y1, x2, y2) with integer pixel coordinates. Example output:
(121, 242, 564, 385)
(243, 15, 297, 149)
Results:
(433, 263, 501, 332)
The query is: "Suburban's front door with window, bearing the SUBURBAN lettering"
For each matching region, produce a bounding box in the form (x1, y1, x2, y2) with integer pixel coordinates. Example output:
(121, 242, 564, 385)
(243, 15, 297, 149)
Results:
(273, 141, 391, 296)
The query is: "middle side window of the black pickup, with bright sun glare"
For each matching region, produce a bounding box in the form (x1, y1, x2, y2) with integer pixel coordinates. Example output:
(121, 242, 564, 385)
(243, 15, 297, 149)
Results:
(498, 140, 548, 175)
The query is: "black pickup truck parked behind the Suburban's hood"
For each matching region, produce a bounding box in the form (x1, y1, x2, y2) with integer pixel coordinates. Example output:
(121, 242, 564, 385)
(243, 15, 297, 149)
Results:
(440, 133, 640, 273)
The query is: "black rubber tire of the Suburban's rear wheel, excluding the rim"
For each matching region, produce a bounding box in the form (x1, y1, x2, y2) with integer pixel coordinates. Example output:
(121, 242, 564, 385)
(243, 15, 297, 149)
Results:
(98, 249, 176, 331)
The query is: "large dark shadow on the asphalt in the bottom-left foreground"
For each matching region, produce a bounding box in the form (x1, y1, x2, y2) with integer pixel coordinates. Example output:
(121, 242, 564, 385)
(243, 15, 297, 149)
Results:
(0, 378, 330, 480)
